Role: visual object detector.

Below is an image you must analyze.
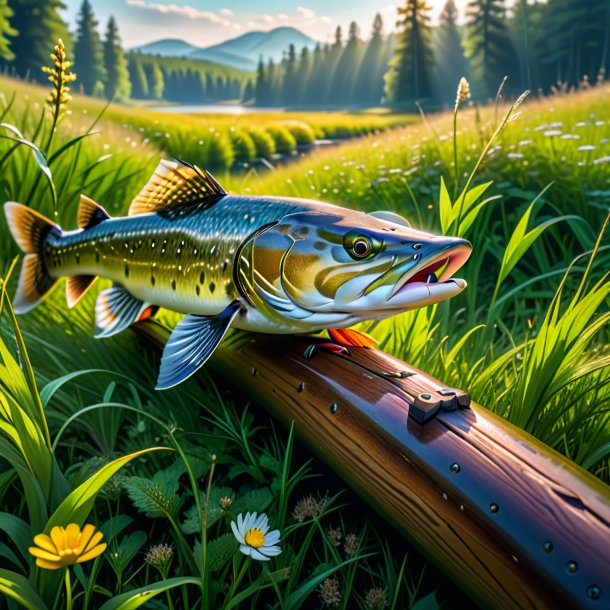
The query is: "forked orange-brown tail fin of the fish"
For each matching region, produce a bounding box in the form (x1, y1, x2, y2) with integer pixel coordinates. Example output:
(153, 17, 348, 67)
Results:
(4, 201, 60, 313)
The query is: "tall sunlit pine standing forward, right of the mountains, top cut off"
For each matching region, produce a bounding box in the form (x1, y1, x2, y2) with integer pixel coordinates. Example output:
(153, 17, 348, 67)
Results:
(385, 0, 433, 104)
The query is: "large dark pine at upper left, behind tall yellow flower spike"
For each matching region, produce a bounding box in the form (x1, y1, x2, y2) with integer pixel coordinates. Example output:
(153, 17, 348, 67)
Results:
(10, 0, 71, 82)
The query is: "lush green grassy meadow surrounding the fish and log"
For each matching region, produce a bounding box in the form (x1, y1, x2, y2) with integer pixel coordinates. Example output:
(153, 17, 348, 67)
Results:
(0, 72, 610, 610)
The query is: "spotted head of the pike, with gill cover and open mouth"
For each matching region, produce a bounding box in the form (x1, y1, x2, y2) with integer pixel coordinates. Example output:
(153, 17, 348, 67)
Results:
(236, 210, 472, 320)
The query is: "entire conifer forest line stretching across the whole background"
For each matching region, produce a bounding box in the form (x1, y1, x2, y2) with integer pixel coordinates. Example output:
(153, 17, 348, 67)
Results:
(0, 0, 610, 107)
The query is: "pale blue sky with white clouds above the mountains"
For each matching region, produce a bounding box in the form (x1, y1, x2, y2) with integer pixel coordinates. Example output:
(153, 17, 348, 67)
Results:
(64, 0, 467, 48)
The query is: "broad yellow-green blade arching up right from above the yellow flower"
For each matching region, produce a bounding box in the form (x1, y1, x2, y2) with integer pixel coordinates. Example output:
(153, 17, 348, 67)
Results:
(45, 447, 169, 533)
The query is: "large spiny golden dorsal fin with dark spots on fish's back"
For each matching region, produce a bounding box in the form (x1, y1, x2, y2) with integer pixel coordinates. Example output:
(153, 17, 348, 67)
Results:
(129, 159, 227, 216)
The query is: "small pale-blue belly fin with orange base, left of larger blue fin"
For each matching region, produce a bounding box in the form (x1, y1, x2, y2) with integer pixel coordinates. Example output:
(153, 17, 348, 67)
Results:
(95, 286, 151, 339)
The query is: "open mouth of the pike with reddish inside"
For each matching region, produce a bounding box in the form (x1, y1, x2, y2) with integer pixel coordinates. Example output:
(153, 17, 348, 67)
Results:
(388, 241, 472, 300)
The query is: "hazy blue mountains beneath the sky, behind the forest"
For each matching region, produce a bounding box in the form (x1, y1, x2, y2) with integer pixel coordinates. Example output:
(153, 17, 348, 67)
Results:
(133, 27, 316, 70)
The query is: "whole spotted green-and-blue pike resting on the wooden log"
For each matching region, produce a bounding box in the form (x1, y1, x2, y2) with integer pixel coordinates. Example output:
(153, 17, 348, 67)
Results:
(4, 159, 472, 389)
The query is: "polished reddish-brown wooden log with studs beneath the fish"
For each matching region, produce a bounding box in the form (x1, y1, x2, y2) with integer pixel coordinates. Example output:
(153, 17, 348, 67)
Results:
(142, 326, 610, 610)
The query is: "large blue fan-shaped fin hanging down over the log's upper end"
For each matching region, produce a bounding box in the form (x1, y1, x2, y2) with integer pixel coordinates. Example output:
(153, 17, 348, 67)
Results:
(157, 301, 240, 390)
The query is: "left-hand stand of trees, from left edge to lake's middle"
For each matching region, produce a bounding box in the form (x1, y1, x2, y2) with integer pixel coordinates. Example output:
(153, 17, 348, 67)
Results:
(0, 0, 252, 103)
